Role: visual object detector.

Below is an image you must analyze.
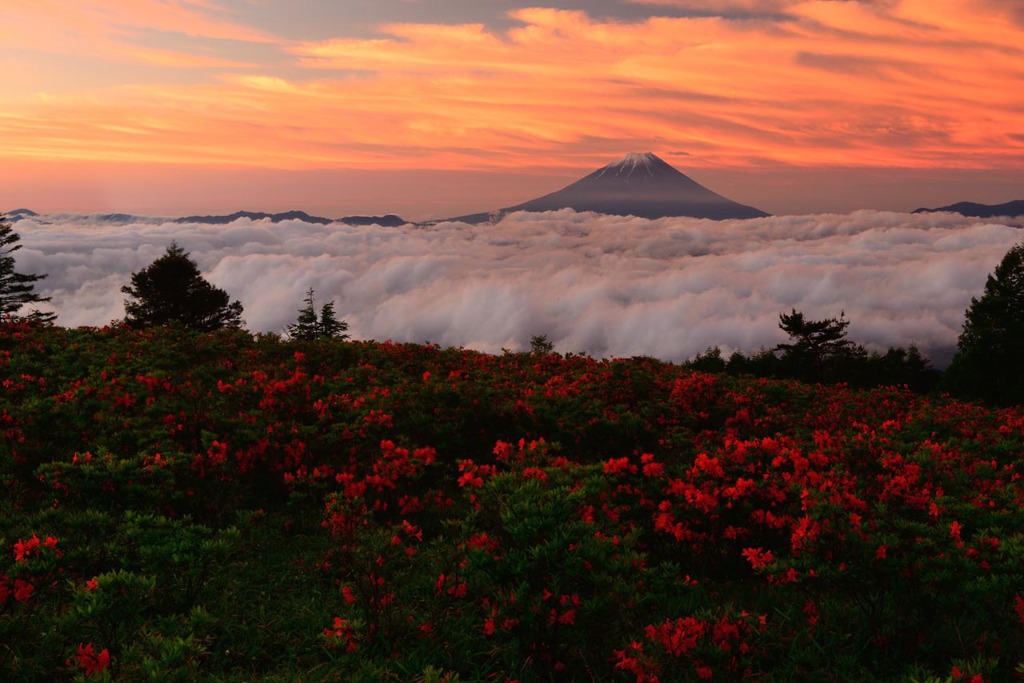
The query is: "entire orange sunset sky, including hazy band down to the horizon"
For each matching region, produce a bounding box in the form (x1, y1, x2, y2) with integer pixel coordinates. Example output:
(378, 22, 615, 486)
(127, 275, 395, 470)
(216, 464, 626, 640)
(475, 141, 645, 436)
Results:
(0, 0, 1024, 219)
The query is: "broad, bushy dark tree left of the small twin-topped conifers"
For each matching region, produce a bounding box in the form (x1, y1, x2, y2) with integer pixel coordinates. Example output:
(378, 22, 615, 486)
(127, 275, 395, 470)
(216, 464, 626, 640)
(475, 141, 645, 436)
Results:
(121, 242, 244, 332)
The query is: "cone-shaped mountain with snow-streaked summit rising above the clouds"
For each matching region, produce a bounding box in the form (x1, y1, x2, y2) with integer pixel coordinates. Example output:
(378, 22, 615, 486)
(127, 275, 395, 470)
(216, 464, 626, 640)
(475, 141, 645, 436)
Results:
(452, 153, 769, 223)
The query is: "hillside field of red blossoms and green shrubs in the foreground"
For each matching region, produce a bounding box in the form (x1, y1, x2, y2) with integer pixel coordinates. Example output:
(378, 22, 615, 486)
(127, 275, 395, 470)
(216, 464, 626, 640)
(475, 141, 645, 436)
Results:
(0, 321, 1024, 683)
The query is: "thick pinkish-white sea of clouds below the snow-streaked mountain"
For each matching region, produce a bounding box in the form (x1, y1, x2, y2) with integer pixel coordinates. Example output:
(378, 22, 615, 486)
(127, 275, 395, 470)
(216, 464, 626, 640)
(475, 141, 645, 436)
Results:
(16, 210, 1024, 362)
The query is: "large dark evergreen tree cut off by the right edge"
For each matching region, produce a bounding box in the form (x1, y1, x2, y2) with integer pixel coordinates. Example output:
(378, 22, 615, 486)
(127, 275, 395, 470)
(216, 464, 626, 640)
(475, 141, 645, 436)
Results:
(945, 243, 1024, 405)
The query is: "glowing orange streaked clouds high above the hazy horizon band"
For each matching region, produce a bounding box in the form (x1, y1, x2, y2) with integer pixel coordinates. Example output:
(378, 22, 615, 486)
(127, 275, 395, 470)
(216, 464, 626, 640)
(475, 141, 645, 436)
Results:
(6, 0, 1024, 184)
